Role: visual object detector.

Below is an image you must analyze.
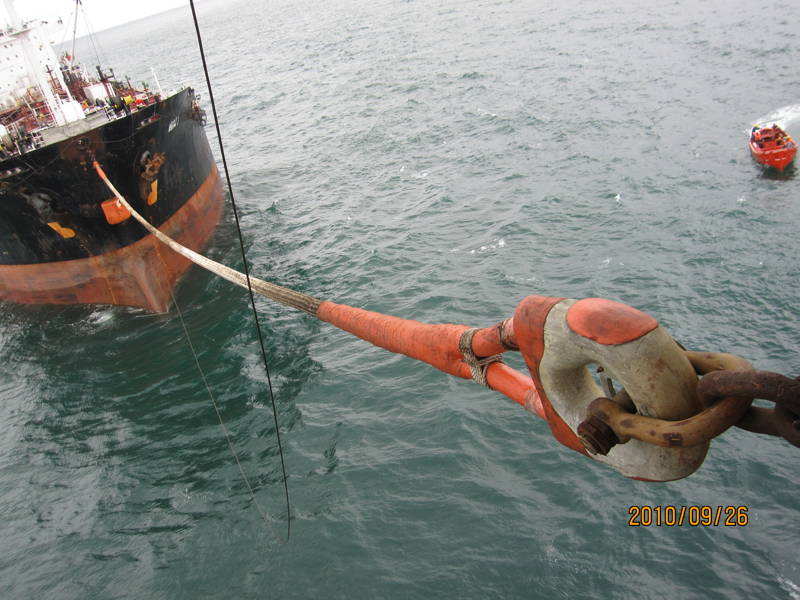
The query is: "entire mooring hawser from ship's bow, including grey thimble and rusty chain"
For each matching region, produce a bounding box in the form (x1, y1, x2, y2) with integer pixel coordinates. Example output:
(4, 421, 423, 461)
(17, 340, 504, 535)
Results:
(95, 162, 800, 481)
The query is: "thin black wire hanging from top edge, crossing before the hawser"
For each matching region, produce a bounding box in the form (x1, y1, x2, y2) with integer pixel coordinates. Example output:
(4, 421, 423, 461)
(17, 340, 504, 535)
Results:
(189, 0, 291, 540)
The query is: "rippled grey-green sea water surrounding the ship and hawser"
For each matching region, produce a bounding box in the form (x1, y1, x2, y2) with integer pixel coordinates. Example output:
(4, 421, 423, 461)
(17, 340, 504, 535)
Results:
(0, 0, 800, 599)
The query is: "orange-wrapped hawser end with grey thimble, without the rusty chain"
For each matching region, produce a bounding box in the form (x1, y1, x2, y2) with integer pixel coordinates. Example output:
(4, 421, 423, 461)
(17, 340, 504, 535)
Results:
(316, 296, 708, 481)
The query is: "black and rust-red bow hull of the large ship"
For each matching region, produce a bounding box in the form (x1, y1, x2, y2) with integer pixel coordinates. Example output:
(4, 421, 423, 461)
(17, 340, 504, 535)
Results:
(0, 88, 223, 312)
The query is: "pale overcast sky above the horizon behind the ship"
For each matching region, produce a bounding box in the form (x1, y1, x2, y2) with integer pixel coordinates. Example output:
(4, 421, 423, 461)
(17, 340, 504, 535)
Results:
(0, 0, 189, 35)
